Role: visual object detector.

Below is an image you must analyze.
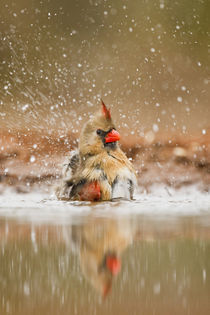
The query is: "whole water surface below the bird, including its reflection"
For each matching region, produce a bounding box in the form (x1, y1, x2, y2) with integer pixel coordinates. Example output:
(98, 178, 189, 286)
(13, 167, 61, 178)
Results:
(0, 194, 210, 315)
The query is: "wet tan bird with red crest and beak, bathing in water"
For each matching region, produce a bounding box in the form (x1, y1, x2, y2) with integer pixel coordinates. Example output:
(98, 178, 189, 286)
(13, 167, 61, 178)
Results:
(57, 101, 136, 201)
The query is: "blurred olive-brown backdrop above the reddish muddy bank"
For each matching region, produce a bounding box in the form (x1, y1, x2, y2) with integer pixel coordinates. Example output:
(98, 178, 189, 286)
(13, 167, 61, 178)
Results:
(0, 0, 210, 136)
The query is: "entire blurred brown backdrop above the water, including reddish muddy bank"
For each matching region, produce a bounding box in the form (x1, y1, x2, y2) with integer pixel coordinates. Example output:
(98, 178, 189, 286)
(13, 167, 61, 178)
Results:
(0, 0, 210, 191)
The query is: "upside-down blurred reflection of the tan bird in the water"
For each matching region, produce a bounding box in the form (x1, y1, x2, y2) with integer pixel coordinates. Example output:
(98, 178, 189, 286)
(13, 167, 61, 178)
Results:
(72, 219, 133, 297)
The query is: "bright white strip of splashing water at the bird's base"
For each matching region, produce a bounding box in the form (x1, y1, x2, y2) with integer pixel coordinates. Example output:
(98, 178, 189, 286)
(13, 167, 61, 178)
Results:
(0, 186, 210, 223)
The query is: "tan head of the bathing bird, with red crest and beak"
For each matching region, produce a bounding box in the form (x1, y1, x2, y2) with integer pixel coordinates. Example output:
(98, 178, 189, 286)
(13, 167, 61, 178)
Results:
(79, 101, 120, 155)
